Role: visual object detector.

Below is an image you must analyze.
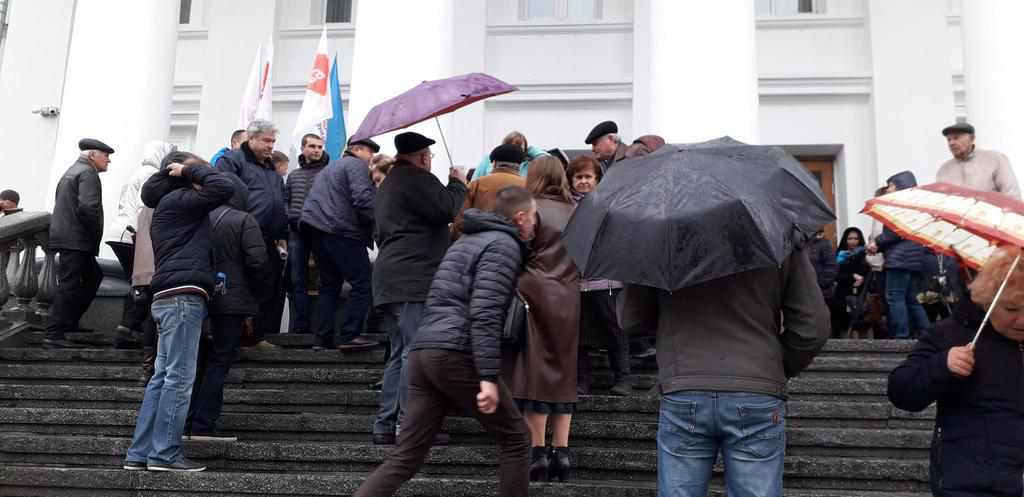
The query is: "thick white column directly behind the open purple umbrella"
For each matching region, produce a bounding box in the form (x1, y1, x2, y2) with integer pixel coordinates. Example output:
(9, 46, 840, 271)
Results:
(346, 0, 452, 180)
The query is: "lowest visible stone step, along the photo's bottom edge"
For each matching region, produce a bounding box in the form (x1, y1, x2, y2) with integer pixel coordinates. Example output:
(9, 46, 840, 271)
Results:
(0, 465, 931, 497)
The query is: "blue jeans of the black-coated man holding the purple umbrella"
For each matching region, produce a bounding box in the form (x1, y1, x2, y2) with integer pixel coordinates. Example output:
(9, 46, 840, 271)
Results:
(374, 302, 423, 433)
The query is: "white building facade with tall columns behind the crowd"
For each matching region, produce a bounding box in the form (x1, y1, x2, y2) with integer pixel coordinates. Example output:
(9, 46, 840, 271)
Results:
(0, 0, 1024, 239)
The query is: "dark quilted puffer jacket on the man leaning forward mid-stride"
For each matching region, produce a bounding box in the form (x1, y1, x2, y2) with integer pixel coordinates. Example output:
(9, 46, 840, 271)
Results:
(412, 209, 526, 378)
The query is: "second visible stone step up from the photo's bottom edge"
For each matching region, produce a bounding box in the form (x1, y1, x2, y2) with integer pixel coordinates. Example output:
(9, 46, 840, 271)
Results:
(0, 433, 928, 483)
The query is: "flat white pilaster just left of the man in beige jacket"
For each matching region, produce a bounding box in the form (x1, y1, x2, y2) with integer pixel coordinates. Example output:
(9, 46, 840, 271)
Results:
(868, 0, 954, 184)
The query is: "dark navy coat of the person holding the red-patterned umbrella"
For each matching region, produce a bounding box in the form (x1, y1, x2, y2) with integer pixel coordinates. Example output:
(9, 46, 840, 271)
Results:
(889, 301, 1024, 497)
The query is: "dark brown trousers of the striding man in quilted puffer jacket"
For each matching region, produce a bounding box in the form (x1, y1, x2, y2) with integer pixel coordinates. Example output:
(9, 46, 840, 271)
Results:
(354, 349, 529, 497)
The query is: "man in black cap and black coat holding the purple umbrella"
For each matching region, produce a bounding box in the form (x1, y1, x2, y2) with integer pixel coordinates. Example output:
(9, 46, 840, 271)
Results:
(373, 132, 468, 444)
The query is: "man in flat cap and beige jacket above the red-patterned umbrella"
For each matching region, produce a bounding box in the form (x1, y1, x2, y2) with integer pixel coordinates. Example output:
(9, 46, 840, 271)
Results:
(935, 123, 1021, 199)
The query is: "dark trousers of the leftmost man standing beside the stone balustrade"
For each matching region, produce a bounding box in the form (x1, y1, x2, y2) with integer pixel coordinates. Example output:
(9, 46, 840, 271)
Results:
(46, 250, 103, 340)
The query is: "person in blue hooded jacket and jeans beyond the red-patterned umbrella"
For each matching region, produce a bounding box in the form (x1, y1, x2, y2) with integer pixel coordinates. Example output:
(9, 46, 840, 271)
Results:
(867, 171, 931, 338)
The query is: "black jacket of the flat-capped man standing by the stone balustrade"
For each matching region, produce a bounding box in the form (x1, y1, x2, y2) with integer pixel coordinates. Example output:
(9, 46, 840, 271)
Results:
(50, 157, 103, 255)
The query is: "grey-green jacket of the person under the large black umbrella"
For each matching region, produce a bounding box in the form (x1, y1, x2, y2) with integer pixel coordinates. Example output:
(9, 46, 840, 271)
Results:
(621, 250, 830, 398)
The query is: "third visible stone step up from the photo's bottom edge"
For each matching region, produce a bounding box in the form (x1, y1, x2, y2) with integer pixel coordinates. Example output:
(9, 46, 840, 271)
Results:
(0, 408, 931, 457)
